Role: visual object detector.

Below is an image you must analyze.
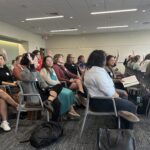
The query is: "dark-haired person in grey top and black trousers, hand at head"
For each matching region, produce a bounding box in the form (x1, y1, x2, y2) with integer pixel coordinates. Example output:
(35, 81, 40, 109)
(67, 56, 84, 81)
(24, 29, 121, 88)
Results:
(19, 53, 62, 121)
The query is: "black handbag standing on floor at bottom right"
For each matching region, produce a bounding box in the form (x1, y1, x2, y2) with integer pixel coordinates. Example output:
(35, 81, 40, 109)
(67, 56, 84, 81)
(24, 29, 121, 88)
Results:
(97, 128, 135, 150)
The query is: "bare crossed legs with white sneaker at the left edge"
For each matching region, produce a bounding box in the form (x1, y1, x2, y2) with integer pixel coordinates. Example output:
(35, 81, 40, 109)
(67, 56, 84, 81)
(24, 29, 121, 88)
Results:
(0, 89, 19, 131)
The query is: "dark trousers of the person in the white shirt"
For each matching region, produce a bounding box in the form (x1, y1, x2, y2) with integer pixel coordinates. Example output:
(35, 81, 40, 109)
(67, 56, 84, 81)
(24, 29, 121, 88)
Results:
(90, 98, 136, 129)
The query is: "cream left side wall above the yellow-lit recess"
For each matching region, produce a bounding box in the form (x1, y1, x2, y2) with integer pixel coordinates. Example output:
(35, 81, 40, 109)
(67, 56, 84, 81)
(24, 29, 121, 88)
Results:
(0, 22, 45, 51)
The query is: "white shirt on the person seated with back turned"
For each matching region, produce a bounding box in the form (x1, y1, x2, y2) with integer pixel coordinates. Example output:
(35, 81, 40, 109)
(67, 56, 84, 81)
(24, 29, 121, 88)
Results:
(84, 66, 115, 97)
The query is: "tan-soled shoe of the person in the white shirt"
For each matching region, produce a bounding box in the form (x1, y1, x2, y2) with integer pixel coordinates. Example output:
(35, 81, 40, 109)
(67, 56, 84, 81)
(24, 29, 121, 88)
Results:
(118, 111, 140, 122)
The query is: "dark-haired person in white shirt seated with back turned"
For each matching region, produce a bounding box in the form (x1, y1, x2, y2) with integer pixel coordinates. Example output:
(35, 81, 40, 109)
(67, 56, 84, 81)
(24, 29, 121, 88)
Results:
(84, 50, 139, 129)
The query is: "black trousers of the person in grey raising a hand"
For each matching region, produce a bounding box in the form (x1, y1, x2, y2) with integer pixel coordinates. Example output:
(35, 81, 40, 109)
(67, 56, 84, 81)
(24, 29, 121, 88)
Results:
(39, 84, 63, 121)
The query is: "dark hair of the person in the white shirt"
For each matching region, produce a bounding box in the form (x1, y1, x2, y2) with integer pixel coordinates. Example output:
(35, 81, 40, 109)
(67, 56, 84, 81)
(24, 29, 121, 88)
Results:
(86, 50, 106, 69)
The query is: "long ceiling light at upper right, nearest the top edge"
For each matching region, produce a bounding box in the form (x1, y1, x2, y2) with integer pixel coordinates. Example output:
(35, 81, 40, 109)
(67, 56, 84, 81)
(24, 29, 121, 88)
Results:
(90, 8, 138, 15)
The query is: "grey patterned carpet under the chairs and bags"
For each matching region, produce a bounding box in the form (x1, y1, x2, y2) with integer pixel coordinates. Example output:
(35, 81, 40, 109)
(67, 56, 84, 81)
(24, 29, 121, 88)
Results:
(0, 110, 150, 150)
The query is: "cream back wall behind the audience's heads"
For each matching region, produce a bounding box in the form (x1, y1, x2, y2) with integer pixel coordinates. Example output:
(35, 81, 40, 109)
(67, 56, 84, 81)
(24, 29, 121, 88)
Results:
(46, 31, 150, 72)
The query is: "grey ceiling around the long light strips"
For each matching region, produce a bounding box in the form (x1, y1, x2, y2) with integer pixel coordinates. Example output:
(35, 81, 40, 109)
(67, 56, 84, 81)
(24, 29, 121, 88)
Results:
(0, 0, 150, 35)
